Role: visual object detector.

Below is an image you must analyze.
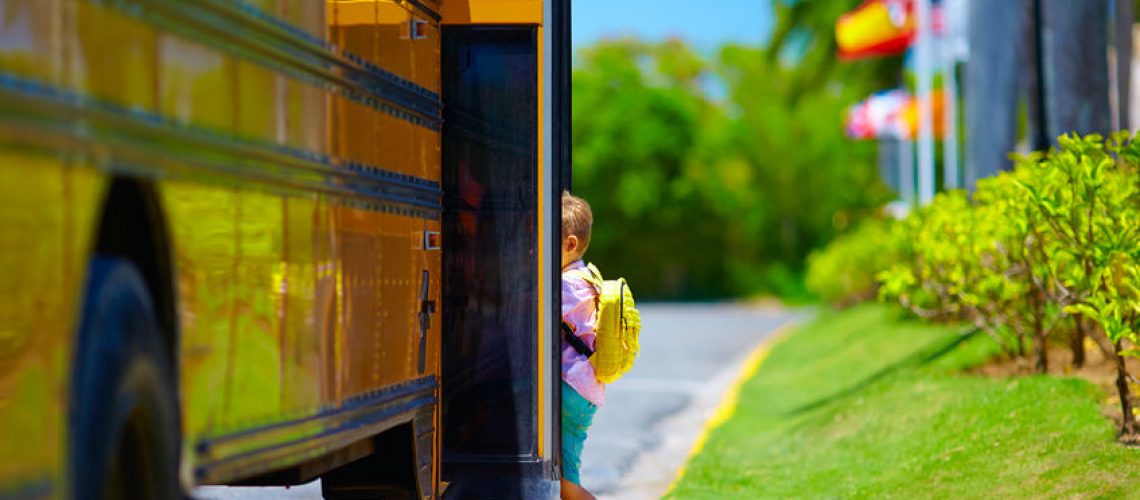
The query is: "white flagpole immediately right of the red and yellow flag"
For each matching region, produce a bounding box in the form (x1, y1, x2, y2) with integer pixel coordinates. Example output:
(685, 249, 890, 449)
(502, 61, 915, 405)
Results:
(914, 0, 935, 205)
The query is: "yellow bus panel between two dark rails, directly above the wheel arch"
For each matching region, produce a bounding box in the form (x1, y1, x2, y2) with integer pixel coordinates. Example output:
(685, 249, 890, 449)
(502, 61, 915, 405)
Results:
(71, 1, 157, 110)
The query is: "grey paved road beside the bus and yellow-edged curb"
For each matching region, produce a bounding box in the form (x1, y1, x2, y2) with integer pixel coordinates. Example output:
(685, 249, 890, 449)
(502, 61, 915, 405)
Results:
(195, 304, 795, 500)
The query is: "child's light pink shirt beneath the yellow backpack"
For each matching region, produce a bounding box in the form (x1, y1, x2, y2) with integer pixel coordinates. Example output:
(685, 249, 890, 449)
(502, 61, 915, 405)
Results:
(562, 260, 605, 407)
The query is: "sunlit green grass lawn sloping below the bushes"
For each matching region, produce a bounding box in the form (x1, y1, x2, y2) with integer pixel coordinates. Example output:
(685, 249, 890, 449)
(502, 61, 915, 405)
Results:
(671, 305, 1140, 498)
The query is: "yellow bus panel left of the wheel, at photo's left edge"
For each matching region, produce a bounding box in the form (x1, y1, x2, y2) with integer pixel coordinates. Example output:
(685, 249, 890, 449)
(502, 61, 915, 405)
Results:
(0, 149, 74, 494)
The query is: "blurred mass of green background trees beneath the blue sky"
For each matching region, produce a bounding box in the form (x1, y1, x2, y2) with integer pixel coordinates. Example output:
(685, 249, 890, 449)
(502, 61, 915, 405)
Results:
(573, 1, 899, 300)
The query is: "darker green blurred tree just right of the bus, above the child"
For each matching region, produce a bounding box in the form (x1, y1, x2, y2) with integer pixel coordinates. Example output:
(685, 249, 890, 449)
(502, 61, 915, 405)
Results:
(572, 40, 724, 298)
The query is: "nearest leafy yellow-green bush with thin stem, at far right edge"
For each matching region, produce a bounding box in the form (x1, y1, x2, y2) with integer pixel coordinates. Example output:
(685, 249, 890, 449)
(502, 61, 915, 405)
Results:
(1018, 132, 1140, 434)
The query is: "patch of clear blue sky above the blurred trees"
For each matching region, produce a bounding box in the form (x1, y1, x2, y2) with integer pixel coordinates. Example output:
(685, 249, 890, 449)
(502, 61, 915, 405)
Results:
(571, 0, 772, 50)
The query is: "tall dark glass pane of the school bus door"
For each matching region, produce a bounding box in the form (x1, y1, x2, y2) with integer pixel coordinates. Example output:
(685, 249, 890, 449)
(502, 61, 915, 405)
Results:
(441, 26, 539, 461)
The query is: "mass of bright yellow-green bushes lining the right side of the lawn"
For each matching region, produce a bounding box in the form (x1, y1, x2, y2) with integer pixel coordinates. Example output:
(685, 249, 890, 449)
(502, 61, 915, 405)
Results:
(870, 132, 1140, 434)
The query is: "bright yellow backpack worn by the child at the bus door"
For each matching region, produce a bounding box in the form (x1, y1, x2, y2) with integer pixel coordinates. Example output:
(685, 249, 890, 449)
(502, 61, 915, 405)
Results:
(576, 264, 641, 384)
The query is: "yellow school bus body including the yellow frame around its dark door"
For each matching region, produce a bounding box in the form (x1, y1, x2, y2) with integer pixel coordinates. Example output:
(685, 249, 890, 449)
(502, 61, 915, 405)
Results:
(0, 0, 570, 497)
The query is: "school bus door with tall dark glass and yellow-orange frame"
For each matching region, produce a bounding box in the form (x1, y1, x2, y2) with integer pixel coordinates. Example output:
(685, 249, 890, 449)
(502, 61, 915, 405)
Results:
(441, 0, 569, 498)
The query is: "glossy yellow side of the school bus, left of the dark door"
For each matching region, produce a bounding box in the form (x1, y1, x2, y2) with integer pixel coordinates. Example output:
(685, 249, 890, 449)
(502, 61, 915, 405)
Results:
(0, 0, 441, 497)
